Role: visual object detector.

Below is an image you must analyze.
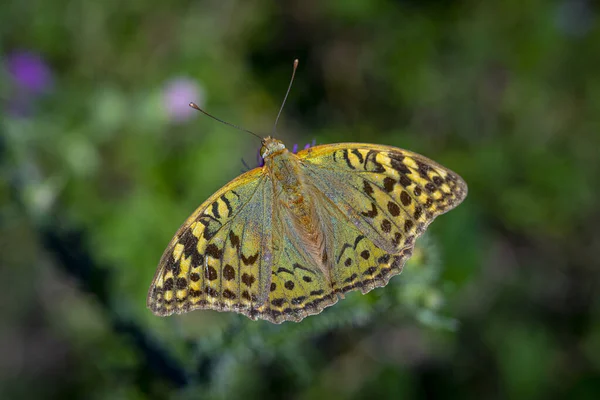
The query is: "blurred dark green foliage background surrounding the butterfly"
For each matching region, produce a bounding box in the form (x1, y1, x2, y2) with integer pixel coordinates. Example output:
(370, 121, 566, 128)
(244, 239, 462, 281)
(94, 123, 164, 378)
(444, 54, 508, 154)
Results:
(0, 0, 600, 399)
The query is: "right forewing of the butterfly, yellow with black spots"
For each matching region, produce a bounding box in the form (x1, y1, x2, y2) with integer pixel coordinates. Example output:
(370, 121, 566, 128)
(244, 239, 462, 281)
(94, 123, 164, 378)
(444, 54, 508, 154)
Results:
(298, 143, 467, 255)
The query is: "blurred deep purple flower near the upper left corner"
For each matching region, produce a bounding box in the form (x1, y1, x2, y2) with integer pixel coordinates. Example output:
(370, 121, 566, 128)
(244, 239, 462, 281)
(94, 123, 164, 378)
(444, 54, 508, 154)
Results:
(4, 50, 54, 95)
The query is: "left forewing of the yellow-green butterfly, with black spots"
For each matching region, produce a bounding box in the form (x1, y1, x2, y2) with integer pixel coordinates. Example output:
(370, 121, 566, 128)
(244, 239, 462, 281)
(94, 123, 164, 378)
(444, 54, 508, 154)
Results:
(147, 168, 273, 319)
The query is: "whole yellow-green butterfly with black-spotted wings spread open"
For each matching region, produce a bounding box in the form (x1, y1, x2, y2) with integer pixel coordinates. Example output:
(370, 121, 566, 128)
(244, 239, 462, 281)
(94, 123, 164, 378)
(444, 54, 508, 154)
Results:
(147, 137, 467, 323)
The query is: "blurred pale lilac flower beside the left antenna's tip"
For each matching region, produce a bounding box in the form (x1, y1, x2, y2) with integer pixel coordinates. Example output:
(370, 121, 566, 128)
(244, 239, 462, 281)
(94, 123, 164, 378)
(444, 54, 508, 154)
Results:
(162, 77, 204, 122)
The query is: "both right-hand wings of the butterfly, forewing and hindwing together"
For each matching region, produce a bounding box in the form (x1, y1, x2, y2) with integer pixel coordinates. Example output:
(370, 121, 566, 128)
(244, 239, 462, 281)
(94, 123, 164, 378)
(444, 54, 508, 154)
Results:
(298, 143, 467, 293)
